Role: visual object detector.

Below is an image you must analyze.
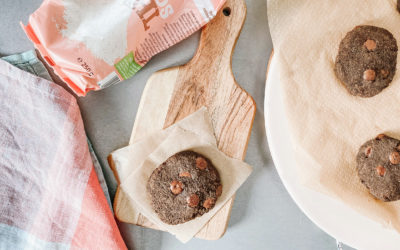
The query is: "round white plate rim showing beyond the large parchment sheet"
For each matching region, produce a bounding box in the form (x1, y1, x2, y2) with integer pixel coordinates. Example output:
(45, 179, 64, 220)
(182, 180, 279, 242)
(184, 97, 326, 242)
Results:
(264, 59, 400, 250)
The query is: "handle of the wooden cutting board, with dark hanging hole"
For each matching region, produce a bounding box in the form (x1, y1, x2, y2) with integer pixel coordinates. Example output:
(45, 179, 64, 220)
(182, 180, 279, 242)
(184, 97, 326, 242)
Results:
(189, 0, 246, 69)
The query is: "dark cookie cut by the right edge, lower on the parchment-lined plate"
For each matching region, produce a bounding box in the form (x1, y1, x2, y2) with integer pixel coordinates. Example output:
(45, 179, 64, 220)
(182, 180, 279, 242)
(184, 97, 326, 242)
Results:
(357, 134, 400, 201)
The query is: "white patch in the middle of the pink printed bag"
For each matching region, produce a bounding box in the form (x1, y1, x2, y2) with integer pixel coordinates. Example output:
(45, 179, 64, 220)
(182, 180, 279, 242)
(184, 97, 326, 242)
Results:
(61, 0, 149, 65)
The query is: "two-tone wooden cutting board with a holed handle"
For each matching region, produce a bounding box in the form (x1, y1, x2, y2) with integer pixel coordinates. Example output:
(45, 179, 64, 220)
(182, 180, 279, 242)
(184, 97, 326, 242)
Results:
(110, 0, 256, 240)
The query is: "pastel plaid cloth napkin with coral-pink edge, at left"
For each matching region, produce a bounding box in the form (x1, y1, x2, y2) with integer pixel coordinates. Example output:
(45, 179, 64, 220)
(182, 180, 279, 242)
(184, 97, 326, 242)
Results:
(0, 52, 126, 249)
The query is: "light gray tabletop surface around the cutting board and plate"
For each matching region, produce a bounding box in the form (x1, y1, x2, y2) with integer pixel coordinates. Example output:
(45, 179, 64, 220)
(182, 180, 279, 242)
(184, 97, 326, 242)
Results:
(0, 0, 350, 250)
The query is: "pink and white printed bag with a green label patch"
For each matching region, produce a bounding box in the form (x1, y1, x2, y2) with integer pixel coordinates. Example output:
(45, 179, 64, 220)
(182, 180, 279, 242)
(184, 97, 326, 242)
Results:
(23, 0, 225, 96)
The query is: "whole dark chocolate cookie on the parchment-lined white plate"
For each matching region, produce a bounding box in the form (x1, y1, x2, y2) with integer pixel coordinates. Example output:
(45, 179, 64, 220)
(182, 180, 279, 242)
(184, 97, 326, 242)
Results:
(335, 25, 398, 97)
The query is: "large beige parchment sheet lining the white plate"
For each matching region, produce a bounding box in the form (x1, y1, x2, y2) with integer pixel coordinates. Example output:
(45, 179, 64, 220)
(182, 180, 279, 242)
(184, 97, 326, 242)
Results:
(268, 0, 400, 234)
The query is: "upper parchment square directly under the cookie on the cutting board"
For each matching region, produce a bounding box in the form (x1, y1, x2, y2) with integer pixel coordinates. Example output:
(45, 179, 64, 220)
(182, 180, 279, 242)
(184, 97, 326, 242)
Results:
(121, 126, 252, 242)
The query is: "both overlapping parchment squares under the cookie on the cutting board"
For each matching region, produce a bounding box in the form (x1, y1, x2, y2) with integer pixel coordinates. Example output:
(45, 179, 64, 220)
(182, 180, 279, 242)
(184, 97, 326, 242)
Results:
(112, 108, 252, 242)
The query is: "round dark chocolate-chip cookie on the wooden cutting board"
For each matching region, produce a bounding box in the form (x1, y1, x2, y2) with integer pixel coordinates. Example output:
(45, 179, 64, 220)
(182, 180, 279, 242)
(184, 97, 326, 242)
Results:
(147, 151, 222, 225)
